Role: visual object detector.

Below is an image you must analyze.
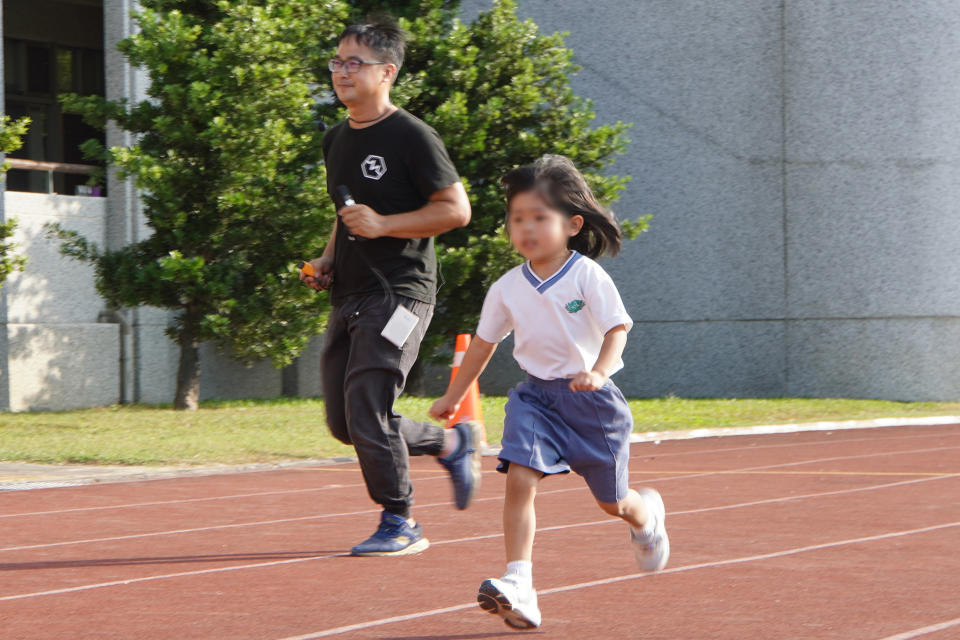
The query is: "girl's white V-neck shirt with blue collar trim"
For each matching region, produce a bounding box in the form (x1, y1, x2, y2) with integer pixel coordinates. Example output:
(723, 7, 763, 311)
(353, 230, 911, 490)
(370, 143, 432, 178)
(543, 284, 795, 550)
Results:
(477, 251, 633, 380)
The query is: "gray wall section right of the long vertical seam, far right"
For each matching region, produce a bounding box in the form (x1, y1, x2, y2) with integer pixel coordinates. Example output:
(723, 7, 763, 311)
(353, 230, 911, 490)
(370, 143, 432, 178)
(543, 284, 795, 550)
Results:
(784, 0, 960, 400)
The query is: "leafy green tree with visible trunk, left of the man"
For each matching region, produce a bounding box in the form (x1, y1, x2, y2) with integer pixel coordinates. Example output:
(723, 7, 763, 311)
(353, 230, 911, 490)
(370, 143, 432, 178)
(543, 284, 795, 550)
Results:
(52, 0, 346, 409)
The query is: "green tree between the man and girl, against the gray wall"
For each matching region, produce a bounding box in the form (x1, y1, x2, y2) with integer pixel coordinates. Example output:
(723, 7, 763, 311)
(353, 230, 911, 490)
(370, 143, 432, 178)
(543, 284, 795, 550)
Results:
(350, 0, 648, 368)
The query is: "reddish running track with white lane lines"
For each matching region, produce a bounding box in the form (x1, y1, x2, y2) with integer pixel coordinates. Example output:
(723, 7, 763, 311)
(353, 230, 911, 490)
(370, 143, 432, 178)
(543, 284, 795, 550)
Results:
(0, 425, 960, 640)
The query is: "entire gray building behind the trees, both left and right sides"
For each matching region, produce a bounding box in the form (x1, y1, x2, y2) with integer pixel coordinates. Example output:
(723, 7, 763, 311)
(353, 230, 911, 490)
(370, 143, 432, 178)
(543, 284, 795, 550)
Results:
(0, 0, 960, 410)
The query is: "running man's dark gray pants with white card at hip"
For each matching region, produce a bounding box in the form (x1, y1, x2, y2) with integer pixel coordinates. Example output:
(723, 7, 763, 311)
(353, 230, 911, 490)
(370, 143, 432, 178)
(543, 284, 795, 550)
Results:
(320, 294, 443, 518)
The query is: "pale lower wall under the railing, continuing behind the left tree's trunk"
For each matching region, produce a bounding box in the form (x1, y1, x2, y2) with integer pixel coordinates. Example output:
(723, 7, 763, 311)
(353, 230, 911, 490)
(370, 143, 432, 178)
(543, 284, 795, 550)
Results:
(0, 185, 288, 411)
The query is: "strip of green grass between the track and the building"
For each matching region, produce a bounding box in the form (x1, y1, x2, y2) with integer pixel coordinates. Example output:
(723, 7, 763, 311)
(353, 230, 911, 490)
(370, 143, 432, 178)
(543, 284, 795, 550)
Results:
(0, 397, 960, 465)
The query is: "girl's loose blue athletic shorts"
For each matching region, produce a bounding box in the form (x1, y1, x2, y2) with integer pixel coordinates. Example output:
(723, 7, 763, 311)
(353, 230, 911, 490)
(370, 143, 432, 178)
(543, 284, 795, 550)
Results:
(497, 376, 633, 502)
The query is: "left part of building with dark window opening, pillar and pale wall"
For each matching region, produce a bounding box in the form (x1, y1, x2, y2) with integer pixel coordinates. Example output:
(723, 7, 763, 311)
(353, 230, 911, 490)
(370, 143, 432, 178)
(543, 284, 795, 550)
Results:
(0, 0, 320, 411)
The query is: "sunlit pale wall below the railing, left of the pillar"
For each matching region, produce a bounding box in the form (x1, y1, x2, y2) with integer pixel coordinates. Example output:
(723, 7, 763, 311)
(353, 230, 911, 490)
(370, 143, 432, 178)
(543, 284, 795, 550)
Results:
(0, 191, 120, 411)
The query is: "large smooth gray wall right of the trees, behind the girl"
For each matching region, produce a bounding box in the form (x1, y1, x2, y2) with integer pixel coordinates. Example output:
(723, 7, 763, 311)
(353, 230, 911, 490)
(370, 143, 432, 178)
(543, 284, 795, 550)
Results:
(464, 0, 960, 400)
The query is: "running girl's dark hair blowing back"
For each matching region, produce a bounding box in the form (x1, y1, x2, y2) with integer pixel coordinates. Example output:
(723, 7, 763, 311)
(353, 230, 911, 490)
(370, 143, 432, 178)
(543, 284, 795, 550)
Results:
(500, 154, 623, 258)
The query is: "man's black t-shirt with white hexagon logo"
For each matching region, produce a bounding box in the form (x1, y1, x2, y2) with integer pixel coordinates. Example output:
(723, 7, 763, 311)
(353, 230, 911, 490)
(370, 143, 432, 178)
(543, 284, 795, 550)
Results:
(323, 109, 460, 304)
